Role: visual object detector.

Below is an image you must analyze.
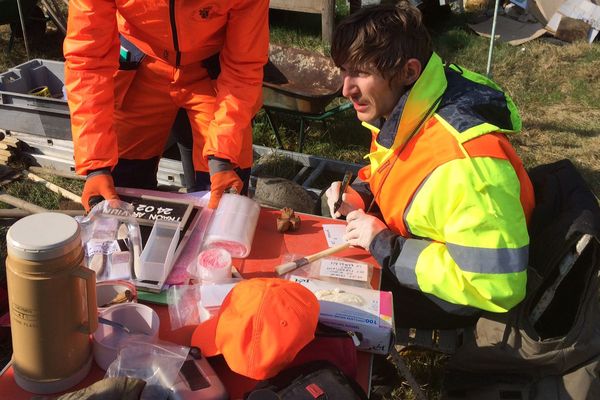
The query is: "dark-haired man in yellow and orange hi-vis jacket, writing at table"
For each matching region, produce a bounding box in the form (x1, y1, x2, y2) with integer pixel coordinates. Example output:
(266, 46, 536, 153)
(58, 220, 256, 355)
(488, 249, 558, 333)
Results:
(326, 2, 534, 328)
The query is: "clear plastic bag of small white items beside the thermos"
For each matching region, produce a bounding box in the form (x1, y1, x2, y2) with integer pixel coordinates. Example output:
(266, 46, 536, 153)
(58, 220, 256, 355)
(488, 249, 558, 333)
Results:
(77, 200, 142, 282)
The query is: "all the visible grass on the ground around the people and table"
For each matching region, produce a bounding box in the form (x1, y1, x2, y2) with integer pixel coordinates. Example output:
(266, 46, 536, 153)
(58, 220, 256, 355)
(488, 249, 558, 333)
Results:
(0, 1, 600, 399)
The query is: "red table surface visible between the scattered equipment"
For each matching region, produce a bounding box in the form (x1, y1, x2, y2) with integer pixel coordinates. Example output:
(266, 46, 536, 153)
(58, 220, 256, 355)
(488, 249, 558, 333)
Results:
(0, 208, 380, 400)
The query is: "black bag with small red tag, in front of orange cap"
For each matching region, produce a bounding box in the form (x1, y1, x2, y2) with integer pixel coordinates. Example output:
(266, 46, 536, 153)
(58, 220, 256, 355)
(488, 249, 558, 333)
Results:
(244, 361, 368, 400)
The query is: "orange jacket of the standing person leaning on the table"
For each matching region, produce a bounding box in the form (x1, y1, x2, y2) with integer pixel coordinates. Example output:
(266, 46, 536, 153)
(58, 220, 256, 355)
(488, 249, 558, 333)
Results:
(64, 0, 269, 174)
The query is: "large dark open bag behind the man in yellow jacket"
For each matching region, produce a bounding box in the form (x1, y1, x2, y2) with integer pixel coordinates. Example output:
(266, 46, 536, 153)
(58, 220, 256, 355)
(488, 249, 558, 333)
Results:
(444, 160, 600, 400)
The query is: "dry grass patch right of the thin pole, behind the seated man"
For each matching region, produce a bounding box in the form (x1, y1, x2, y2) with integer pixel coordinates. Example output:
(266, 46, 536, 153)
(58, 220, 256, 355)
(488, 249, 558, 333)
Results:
(495, 41, 600, 195)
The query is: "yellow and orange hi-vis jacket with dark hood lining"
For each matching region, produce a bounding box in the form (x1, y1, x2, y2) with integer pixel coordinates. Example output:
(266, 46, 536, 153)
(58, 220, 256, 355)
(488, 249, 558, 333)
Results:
(359, 53, 535, 314)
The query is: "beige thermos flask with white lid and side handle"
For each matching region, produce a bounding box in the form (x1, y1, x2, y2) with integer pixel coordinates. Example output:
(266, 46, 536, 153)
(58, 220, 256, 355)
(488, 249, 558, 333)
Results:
(6, 212, 98, 394)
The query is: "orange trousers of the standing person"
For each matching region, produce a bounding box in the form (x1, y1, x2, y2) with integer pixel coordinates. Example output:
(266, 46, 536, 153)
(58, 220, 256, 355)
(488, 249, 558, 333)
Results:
(114, 56, 252, 188)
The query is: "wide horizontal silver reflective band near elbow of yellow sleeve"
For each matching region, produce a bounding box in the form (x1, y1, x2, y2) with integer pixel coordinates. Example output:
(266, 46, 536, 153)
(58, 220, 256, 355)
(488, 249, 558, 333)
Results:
(446, 243, 529, 274)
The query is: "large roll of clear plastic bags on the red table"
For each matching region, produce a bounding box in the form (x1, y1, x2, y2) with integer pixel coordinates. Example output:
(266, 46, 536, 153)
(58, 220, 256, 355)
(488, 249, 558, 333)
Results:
(204, 193, 260, 258)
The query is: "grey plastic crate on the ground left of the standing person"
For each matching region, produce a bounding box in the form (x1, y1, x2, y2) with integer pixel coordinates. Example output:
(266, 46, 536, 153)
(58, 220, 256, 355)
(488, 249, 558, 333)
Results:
(0, 59, 71, 139)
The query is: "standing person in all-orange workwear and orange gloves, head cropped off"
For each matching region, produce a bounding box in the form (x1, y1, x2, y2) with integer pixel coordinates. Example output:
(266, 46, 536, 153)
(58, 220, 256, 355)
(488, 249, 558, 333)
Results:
(64, 0, 269, 208)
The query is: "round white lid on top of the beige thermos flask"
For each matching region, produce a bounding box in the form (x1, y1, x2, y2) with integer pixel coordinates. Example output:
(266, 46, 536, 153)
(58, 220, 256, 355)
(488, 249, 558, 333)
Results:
(6, 212, 81, 261)
